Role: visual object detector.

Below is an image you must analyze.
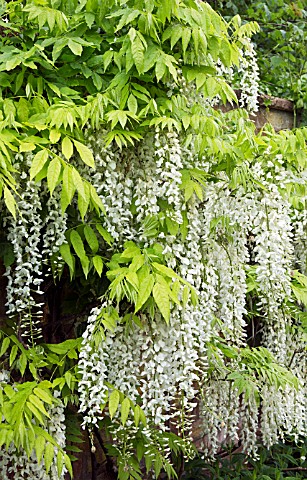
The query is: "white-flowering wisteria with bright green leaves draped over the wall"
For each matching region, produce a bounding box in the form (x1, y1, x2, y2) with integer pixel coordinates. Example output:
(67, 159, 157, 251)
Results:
(0, 0, 307, 480)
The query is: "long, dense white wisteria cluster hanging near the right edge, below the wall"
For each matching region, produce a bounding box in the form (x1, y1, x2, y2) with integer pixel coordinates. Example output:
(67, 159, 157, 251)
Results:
(252, 163, 293, 362)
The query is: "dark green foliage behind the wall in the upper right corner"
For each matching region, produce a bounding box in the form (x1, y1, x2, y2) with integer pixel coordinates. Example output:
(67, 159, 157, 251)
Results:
(210, 0, 307, 121)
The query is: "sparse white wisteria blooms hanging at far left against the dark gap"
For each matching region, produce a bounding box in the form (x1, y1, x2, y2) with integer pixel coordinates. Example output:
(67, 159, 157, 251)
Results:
(3, 158, 67, 344)
